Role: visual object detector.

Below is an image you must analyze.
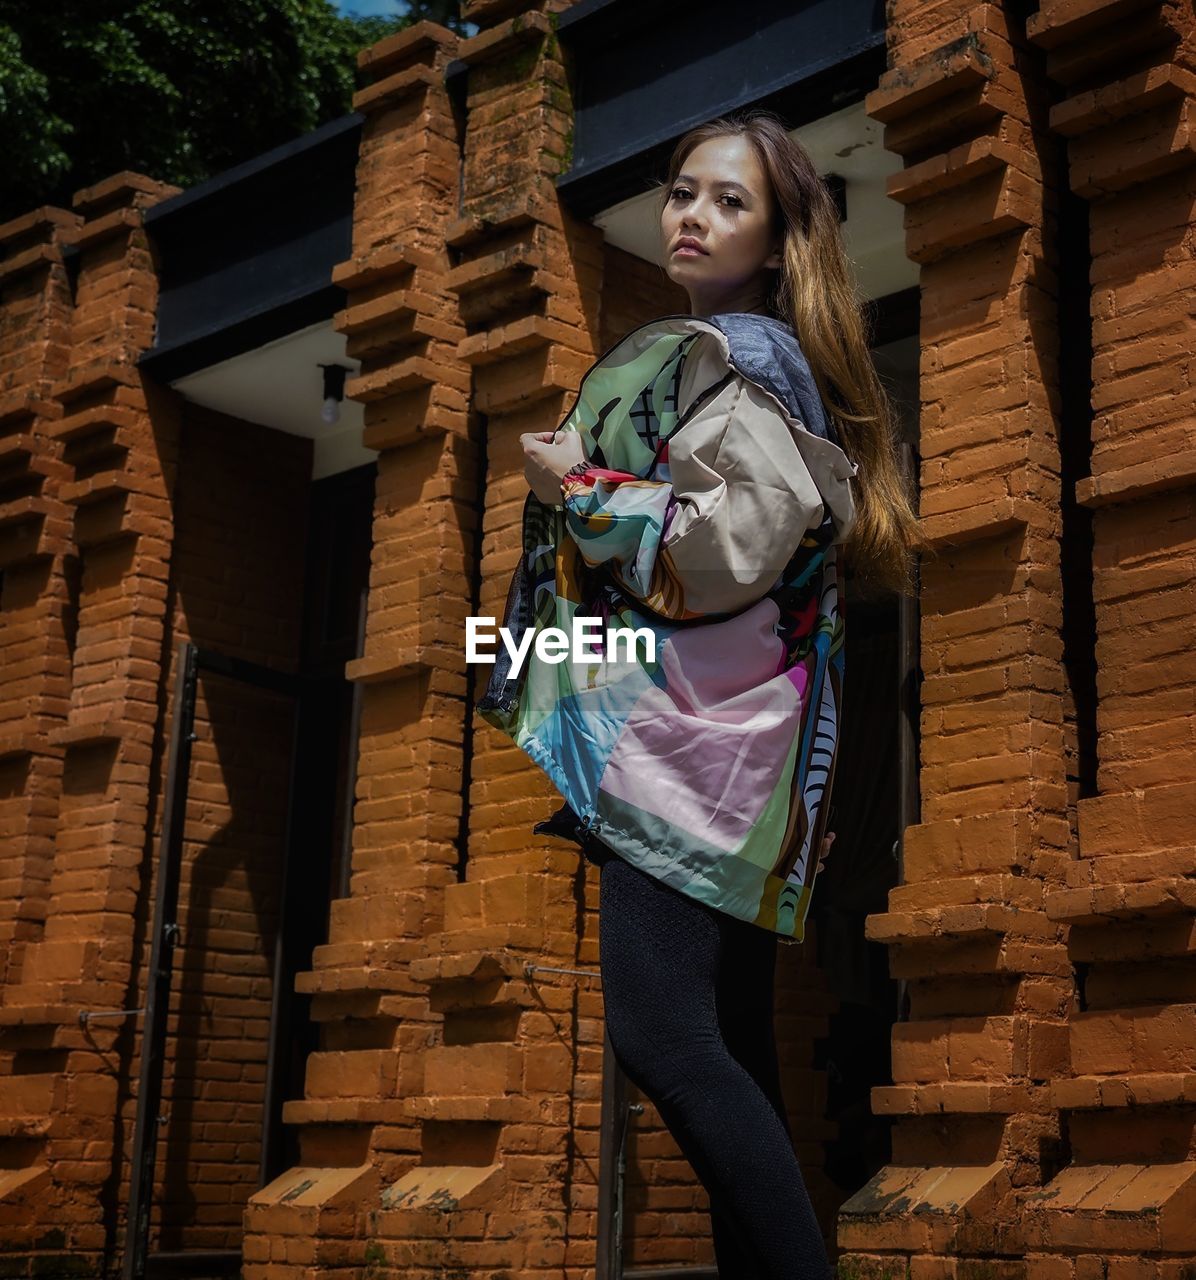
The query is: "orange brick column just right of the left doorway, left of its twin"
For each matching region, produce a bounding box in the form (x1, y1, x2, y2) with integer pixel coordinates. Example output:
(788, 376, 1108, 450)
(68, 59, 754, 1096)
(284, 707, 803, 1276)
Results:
(245, 22, 481, 1280)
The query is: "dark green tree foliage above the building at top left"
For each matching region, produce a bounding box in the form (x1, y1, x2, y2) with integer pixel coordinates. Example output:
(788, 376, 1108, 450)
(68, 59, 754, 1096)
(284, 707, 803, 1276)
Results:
(0, 0, 475, 221)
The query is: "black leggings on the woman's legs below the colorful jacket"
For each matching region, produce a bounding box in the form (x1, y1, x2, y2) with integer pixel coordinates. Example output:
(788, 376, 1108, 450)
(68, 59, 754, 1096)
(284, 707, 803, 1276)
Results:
(590, 847, 831, 1280)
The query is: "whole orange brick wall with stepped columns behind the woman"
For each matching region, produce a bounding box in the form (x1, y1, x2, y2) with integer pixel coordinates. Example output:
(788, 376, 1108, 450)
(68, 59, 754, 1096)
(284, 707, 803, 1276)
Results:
(0, 0, 1196, 1280)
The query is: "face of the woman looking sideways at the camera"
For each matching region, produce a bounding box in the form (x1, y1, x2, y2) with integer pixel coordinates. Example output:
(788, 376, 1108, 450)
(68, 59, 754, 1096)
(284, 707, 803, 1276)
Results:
(661, 134, 781, 316)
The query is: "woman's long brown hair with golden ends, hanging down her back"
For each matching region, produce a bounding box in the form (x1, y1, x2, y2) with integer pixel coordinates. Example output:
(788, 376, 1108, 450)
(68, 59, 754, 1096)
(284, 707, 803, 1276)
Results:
(659, 108, 928, 594)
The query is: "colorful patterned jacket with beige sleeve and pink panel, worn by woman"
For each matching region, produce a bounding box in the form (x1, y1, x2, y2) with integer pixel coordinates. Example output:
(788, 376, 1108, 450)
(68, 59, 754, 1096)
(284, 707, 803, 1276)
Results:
(476, 312, 858, 942)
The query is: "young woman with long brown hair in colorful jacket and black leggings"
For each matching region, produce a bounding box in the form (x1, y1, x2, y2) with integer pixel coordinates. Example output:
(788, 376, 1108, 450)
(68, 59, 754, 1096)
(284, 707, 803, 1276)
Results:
(478, 110, 922, 1280)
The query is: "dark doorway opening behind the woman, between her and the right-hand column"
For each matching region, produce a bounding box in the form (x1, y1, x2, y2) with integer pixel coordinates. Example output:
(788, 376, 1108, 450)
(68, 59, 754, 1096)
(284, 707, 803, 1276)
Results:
(811, 327, 921, 1197)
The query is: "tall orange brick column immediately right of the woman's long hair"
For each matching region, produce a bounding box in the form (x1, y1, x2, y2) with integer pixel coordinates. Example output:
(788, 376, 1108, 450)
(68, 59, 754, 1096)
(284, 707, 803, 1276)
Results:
(839, 0, 1073, 1277)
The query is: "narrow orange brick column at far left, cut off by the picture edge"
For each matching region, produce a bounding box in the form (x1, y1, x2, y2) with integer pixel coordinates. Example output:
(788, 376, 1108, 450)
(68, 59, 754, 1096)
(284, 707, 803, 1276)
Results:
(0, 209, 82, 984)
